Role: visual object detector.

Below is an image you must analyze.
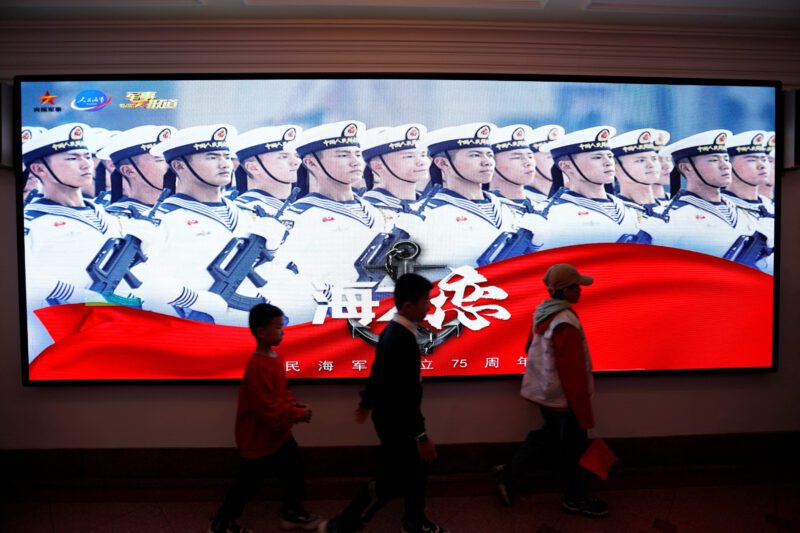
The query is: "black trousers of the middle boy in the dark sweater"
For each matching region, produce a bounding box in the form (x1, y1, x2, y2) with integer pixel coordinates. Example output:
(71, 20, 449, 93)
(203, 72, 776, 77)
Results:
(332, 432, 428, 532)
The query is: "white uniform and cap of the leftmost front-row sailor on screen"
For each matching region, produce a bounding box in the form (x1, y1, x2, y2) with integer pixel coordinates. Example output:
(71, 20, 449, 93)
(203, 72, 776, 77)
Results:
(23, 123, 122, 361)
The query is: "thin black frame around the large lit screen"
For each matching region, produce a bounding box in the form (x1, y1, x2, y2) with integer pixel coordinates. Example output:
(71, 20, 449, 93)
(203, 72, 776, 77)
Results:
(12, 72, 784, 387)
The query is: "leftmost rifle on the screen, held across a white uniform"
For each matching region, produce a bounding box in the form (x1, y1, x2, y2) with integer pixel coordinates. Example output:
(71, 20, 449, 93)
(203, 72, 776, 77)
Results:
(86, 235, 147, 295)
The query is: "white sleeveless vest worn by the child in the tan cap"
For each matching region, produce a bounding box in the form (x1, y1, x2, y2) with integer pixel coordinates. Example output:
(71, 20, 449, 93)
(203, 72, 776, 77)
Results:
(520, 309, 594, 409)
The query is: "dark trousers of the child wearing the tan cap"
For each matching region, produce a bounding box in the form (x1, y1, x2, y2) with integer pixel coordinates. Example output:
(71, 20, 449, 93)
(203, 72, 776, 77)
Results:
(504, 407, 589, 499)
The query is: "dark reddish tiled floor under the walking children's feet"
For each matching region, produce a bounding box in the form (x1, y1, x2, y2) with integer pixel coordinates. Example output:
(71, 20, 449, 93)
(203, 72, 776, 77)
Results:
(0, 469, 800, 533)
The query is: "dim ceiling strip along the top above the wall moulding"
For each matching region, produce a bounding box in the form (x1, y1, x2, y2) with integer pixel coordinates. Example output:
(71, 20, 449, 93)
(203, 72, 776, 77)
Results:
(0, 0, 800, 31)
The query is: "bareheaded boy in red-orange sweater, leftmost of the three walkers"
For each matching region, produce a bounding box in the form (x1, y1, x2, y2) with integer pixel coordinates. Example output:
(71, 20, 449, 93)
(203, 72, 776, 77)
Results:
(208, 304, 320, 533)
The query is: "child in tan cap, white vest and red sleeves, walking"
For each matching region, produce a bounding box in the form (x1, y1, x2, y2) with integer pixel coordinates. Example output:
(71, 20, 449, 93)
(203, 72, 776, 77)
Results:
(495, 263, 608, 518)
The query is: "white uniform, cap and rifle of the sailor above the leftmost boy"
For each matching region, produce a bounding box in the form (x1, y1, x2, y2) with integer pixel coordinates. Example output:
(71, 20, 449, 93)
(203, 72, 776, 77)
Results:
(132, 124, 286, 326)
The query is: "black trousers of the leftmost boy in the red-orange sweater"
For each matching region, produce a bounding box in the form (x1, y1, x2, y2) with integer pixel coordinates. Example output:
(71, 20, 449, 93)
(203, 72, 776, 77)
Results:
(214, 437, 305, 522)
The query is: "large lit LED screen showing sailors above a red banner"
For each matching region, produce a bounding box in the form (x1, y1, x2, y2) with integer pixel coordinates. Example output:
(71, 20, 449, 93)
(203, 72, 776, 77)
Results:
(17, 75, 778, 383)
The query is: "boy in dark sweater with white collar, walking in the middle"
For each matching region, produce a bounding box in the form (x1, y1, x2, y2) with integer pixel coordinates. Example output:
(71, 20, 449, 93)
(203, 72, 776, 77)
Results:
(320, 274, 447, 533)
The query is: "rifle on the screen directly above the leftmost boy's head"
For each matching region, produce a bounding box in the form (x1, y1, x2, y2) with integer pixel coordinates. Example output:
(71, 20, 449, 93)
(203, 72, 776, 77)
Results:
(208, 234, 273, 311)
